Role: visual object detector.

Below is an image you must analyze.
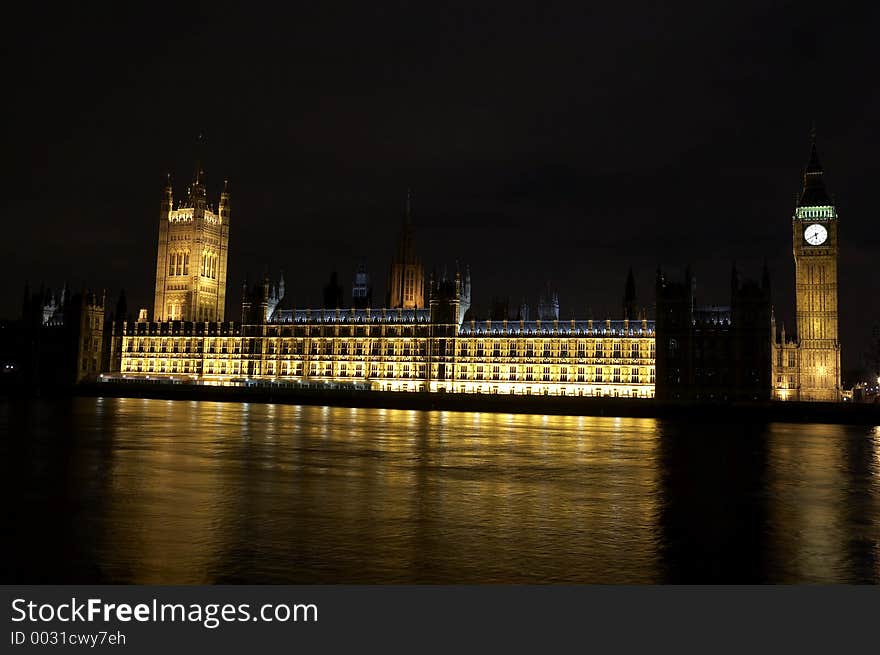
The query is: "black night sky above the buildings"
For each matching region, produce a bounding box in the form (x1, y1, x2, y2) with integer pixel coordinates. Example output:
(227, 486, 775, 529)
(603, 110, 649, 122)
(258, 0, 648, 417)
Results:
(0, 1, 880, 372)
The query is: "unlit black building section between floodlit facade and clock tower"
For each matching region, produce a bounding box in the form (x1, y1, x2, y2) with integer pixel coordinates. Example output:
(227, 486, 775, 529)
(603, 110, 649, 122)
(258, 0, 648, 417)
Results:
(656, 267, 773, 401)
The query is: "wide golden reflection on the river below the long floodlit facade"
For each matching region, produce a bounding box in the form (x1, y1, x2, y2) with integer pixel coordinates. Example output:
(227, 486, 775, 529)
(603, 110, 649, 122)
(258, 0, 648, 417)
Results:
(96, 399, 659, 583)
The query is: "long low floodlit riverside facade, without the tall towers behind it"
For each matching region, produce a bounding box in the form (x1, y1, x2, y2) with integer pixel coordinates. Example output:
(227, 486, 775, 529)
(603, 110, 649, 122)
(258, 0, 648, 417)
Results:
(117, 280, 655, 398)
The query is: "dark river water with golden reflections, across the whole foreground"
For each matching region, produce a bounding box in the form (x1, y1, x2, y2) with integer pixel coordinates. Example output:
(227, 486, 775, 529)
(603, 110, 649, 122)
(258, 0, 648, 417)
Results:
(0, 398, 880, 584)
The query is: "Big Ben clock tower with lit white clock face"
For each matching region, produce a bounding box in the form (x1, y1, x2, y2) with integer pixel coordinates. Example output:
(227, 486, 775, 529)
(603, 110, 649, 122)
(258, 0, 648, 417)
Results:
(792, 132, 840, 402)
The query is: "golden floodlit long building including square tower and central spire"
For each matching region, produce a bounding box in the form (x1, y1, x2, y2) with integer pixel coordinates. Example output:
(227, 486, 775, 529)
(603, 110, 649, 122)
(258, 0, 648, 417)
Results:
(111, 169, 655, 398)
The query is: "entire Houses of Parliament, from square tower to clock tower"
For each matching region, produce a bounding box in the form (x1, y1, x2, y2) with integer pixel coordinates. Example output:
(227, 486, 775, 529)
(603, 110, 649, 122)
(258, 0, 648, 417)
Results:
(109, 136, 840, 401)
